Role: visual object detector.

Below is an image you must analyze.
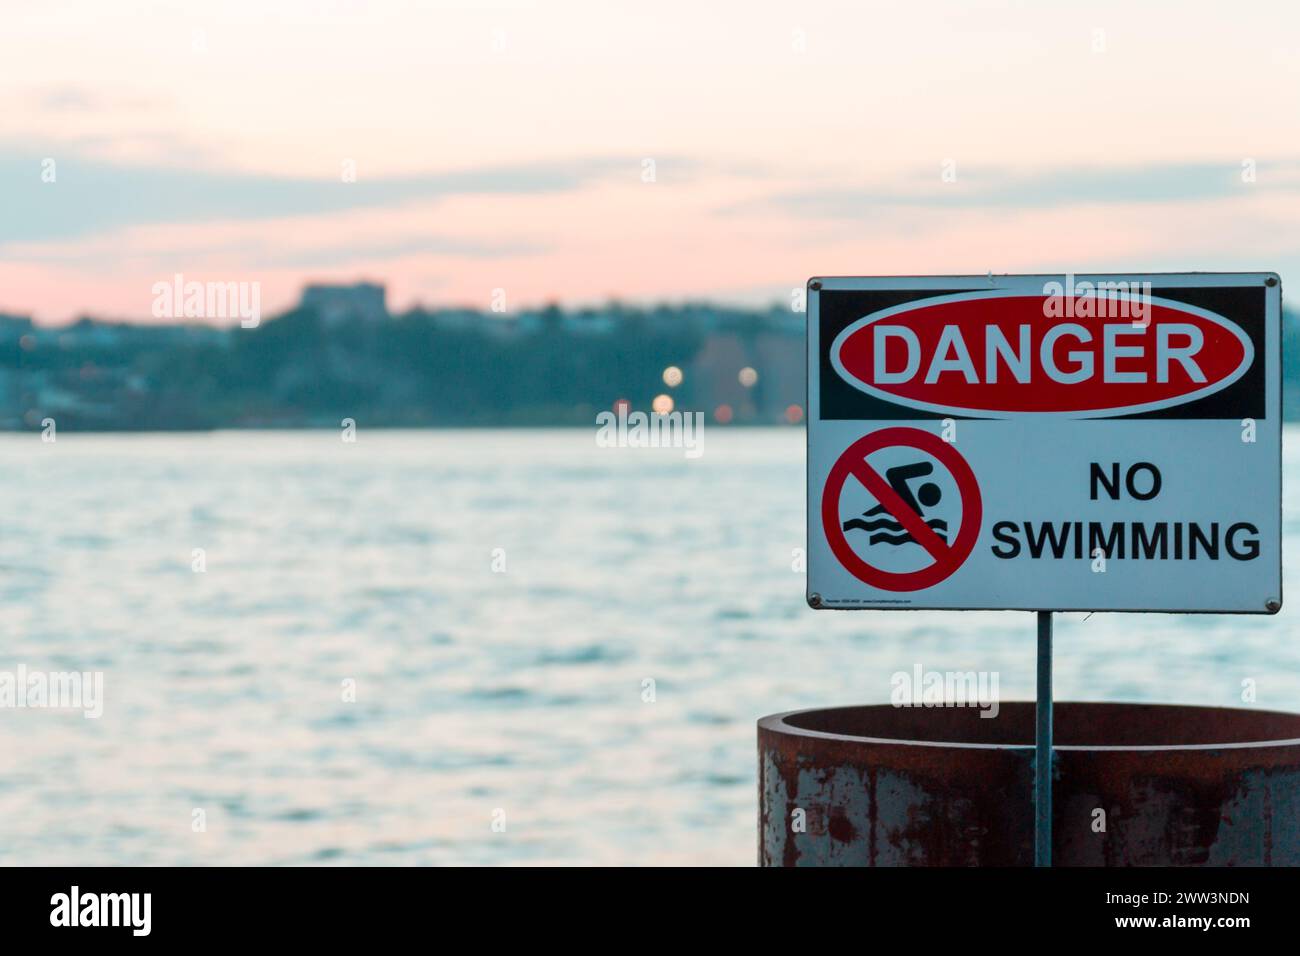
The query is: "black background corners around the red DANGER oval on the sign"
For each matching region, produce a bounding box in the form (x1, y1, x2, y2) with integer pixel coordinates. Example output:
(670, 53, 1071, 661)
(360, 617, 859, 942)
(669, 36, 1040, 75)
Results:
(818, 285, 1268, 421)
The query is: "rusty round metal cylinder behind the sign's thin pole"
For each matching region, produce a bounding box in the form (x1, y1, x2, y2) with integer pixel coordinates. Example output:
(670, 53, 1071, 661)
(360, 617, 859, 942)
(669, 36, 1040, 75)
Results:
(758, 701, 1300, 866)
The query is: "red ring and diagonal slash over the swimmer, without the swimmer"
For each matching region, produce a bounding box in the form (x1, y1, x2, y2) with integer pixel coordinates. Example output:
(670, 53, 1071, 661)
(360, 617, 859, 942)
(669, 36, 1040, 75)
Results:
(822, 428, 983, 591)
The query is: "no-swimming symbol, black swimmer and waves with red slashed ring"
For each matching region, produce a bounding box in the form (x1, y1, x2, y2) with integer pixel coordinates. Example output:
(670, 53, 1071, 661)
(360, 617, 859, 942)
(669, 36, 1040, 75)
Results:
(822, 428, 983, 591)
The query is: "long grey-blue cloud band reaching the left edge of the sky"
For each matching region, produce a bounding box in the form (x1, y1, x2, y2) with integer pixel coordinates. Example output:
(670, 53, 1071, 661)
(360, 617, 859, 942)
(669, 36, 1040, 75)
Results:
(0, 144, 640, 247)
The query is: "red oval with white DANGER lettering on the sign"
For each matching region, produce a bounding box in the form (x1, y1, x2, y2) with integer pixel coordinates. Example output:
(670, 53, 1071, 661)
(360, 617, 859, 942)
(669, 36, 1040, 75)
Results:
(832, 293, 1255, 415)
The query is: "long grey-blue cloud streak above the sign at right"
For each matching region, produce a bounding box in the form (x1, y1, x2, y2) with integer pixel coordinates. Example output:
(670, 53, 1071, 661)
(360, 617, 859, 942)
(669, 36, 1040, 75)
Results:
(748, 160, 1300, 221)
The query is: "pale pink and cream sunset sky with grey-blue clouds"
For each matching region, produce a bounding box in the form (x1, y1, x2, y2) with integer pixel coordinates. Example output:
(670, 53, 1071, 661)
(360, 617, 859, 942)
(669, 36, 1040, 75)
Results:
(0, 0, 1300, 324)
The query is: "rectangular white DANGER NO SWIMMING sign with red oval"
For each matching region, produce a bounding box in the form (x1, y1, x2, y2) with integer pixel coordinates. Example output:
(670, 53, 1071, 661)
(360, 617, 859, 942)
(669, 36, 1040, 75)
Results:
(809, 273, 1282, 613)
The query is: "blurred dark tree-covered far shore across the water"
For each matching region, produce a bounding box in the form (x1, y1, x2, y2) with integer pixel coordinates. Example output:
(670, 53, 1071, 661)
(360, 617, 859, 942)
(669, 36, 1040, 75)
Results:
(0, 303, 1300, 431)
